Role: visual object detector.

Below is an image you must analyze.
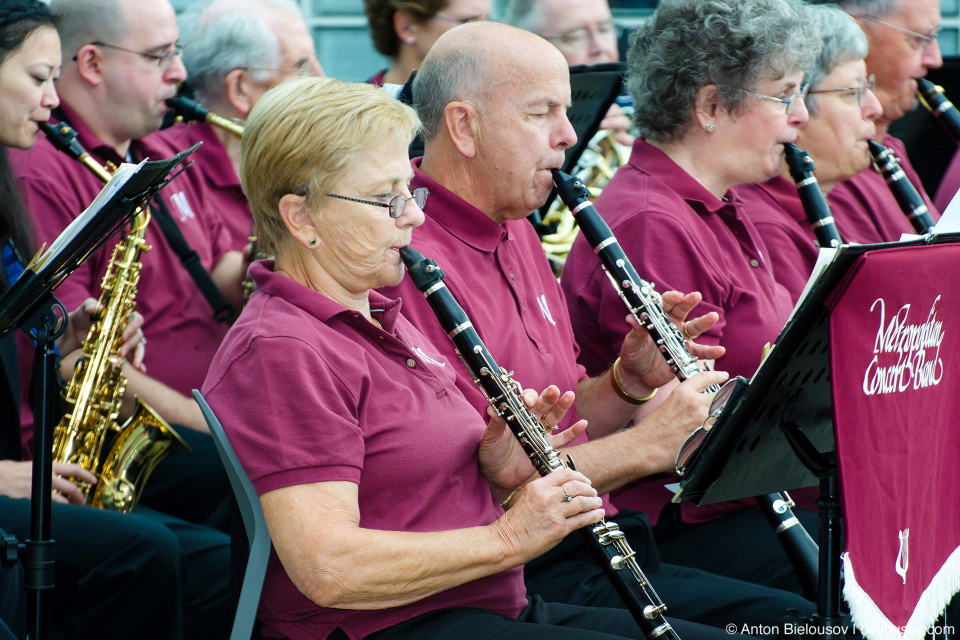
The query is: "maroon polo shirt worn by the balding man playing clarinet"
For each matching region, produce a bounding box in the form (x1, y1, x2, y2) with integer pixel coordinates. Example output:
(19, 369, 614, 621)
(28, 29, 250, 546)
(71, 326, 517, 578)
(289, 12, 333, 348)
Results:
(381, 158, 614, 515)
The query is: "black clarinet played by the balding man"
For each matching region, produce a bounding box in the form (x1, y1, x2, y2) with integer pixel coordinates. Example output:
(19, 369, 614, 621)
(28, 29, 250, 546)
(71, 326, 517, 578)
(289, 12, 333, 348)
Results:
(553, 169, 819, 596)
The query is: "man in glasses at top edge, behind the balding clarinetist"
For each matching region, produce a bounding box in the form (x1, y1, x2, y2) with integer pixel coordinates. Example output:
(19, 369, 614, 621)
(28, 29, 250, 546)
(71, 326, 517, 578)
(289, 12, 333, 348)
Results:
(504, 0, 633, 145)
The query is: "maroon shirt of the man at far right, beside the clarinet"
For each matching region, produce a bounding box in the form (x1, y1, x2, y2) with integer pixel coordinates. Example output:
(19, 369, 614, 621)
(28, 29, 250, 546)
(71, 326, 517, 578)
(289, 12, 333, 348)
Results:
(827, 134, 940, 244)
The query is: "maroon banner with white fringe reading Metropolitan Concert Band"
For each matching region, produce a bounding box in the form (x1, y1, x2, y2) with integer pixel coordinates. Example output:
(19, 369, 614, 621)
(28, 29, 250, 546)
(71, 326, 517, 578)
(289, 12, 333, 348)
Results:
(830, 244, 960, 640)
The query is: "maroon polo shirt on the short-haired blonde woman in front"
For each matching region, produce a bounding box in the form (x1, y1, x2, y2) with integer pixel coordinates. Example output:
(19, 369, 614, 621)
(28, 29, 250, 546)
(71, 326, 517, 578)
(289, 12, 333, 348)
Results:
(203, 260, 526, 640)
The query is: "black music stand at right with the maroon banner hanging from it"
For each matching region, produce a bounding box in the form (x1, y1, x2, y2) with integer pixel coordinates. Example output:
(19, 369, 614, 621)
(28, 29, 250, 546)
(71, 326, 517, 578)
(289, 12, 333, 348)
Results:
(673, 234, 960, 638)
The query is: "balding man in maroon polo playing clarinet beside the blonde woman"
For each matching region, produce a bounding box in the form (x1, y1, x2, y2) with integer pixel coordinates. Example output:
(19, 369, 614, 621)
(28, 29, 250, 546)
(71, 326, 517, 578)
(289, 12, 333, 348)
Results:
(384, 17, 813, 636)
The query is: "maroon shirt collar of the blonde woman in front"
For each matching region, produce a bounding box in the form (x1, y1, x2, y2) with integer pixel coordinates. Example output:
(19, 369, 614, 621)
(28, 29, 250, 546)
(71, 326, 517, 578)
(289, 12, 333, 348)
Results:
(250, 260, 401, 333)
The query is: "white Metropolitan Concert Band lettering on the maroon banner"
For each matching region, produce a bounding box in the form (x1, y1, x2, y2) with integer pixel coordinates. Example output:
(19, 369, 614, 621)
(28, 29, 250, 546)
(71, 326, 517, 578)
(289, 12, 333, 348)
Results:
(863, 296, 944, 396)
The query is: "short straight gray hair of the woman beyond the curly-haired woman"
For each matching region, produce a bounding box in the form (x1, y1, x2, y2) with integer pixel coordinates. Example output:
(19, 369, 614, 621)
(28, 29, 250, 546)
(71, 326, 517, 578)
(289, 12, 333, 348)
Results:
(803, 5, 868, 116)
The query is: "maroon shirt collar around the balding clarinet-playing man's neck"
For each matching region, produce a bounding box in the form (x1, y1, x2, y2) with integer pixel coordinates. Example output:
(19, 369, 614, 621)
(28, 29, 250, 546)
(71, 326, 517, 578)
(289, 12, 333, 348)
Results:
(410, 158, 507, 253)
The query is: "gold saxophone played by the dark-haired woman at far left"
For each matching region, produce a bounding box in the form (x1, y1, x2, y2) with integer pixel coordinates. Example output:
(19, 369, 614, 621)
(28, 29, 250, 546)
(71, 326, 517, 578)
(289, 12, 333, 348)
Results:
(44, 124, 190, 513)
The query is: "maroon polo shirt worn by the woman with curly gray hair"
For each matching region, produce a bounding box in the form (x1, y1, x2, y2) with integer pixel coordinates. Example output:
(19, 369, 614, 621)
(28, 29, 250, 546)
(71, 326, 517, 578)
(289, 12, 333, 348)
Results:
(561, 139, 793, 522)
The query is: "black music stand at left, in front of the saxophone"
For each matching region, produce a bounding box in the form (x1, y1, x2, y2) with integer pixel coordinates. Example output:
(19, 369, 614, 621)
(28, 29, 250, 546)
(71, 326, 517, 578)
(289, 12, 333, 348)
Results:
(0, 143, 200, 640)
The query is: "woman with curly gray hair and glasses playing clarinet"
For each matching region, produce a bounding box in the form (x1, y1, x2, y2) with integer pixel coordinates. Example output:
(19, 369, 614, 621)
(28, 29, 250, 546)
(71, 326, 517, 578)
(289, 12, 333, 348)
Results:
(562, 0, 820, 591)
